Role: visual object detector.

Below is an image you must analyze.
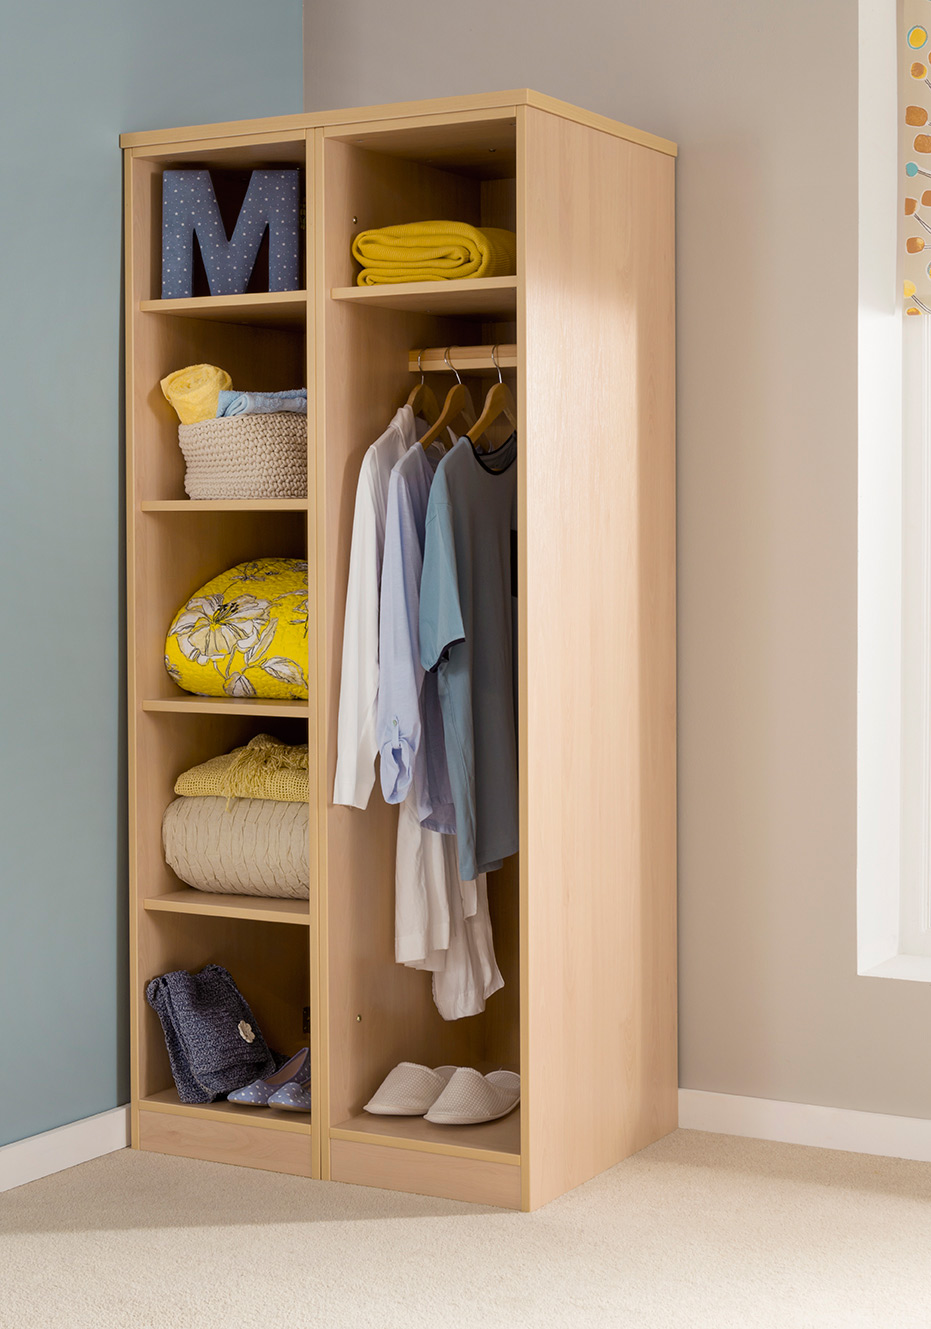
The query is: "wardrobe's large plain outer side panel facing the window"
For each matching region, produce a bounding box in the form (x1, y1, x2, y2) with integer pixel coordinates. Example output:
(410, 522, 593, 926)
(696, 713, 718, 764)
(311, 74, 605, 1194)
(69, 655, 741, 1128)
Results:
(518, 108, 677, 1208)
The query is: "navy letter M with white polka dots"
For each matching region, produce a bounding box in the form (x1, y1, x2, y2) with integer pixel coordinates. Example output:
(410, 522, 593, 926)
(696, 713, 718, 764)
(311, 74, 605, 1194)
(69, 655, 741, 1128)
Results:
(162, 170, 300, 300)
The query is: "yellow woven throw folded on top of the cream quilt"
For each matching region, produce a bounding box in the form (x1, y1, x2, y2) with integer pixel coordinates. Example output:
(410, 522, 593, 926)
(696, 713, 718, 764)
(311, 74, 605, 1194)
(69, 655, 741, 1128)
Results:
(174, 734, 309, 803)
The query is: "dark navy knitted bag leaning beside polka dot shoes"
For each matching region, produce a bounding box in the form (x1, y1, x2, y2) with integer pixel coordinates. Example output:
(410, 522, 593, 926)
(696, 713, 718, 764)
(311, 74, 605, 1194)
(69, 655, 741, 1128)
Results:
(146, 965, 276, 1103)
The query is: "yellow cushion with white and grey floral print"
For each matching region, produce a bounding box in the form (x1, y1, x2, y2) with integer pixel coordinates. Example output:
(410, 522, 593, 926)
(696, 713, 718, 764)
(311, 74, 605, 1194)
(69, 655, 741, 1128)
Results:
(165, 558, 308, 700)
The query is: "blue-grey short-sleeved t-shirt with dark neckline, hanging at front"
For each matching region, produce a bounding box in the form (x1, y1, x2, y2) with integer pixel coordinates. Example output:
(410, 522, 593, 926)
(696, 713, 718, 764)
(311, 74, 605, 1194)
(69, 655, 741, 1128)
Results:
(420, 433, 519, 881)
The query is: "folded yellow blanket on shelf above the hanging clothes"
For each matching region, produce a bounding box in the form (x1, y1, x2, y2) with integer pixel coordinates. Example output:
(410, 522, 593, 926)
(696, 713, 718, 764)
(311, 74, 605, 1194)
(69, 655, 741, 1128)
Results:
(352, 222, 517, 286)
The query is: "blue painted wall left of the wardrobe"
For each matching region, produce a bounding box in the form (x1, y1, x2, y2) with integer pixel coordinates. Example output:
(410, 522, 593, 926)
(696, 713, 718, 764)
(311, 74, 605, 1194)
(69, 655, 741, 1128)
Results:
(0, 0, 303, 1146)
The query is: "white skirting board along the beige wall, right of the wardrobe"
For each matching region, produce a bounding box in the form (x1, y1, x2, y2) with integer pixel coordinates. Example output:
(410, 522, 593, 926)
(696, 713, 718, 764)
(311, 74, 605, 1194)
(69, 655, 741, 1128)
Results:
(679, 1088, 931, 1163)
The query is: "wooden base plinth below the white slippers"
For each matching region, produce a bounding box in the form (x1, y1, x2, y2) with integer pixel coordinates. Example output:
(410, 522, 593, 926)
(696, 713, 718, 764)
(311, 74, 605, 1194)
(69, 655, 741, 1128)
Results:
(329, 1140, 521, 1209)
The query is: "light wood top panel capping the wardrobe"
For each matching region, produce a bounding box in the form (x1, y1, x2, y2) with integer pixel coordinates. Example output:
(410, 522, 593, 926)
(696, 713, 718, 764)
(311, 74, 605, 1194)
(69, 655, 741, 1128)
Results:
(120, 88, 677, 157)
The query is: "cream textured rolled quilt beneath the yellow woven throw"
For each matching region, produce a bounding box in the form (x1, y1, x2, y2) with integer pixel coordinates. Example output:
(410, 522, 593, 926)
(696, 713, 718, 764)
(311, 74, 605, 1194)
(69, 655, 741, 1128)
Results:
(162, 797, 311, 900)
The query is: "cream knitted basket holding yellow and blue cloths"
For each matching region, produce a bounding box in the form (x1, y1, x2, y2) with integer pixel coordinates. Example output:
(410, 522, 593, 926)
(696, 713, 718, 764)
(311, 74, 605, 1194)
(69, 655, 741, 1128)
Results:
(178, 411, 307, 498)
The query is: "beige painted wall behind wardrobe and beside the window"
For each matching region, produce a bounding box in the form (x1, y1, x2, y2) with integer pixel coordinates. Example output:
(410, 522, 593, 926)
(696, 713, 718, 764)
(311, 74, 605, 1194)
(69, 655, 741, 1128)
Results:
(304, 0, 931, 1116)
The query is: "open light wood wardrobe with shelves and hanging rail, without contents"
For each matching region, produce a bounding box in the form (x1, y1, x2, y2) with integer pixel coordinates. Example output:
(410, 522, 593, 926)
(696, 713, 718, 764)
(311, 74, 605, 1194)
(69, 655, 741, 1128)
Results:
(122, 90, 677, 1209)
